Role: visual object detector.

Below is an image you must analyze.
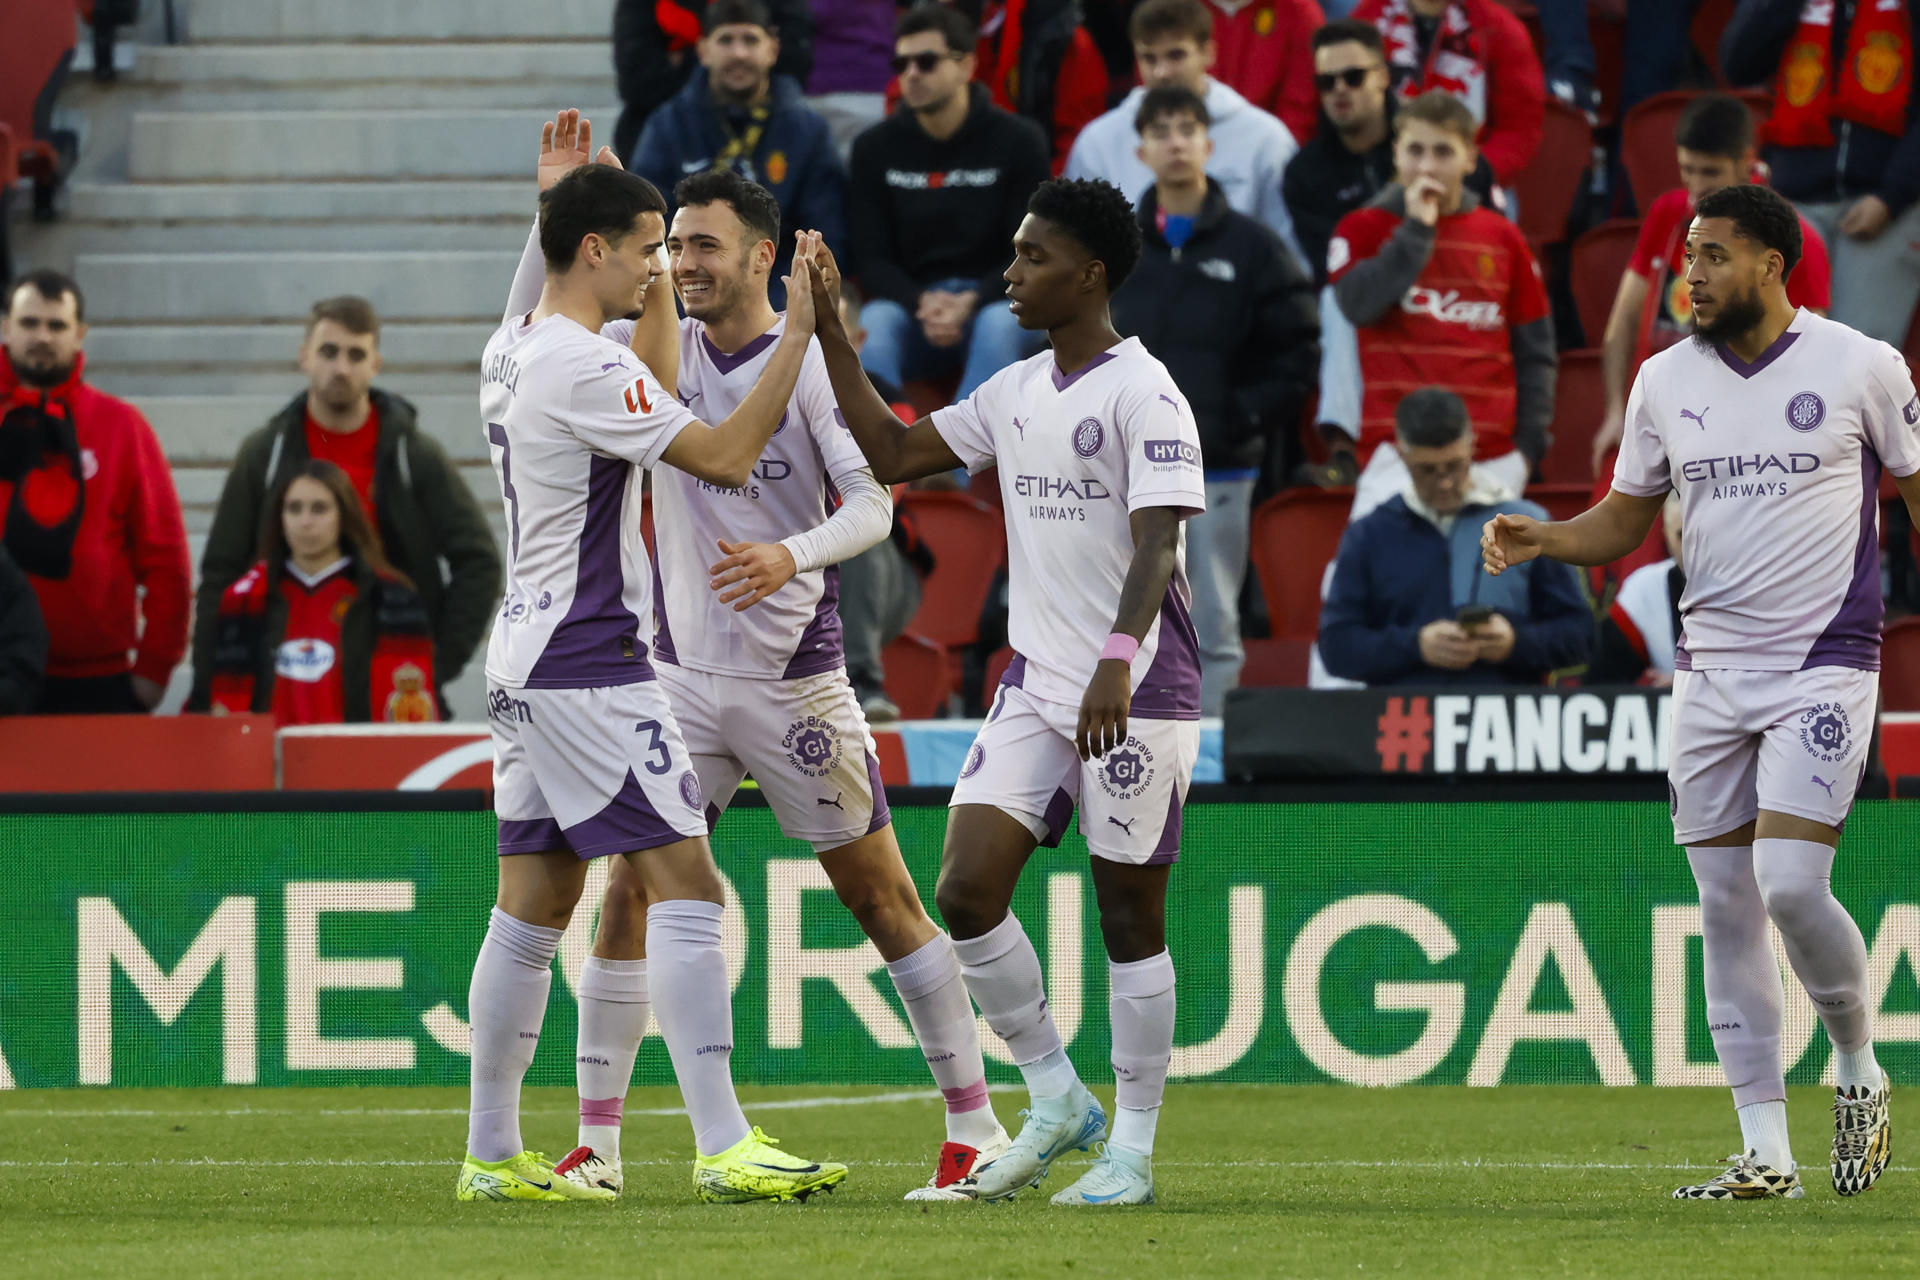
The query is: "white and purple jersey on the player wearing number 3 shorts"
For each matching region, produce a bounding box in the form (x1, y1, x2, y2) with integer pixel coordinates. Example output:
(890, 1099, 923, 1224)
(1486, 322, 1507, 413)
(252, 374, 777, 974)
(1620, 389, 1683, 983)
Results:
(480, 315, 695, 689)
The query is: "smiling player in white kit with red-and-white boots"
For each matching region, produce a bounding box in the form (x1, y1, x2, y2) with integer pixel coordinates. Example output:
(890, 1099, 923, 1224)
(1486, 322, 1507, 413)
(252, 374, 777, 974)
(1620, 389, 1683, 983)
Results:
(541, 169, 1008, 1199)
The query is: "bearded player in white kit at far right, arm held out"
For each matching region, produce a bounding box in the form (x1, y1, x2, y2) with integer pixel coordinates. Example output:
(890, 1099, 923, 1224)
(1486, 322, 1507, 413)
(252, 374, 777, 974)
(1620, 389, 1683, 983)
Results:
(1480, 184, 1920, 1199)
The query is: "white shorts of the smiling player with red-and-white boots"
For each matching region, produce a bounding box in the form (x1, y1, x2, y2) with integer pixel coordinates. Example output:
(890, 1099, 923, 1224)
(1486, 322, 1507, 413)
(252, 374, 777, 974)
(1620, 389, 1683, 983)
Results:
(655, 662, 893, 854)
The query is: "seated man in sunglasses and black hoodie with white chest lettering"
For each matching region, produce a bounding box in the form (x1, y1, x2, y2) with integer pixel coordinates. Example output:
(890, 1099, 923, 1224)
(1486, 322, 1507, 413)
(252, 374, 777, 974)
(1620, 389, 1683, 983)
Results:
(847, 0, 1050, 399)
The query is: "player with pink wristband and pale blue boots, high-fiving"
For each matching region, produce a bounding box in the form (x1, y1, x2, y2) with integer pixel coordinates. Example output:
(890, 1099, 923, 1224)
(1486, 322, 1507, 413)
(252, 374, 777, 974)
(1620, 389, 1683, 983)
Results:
(814, 180, 1206, 1205)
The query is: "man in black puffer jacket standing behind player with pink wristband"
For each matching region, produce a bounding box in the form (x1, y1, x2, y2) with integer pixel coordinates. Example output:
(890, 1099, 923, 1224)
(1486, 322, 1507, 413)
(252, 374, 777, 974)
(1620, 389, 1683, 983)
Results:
(1114, 88, 1319, 716)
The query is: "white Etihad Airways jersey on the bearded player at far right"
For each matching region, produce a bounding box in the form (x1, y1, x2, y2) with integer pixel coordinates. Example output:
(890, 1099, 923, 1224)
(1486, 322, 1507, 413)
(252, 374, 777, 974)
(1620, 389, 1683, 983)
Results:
(1613, 311, 1920, 672)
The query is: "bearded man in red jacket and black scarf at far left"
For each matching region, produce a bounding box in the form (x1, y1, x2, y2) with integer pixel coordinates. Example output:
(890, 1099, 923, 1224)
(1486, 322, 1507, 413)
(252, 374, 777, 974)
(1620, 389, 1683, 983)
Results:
(0, 271, 190, 714)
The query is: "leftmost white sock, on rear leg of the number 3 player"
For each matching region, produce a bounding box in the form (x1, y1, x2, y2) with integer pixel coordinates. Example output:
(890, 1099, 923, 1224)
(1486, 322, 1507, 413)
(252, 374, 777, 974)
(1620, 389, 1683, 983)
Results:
(467, 908, 561, 1163)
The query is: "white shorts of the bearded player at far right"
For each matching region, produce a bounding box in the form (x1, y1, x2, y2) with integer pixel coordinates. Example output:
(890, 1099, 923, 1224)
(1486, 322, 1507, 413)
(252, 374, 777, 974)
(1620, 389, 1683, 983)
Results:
(1667, 666, 1880, 844)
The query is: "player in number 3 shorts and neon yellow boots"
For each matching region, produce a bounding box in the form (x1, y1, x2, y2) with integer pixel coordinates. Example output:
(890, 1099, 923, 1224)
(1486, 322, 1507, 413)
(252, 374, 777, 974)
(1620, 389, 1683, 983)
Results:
(457, 111, 847, 1201)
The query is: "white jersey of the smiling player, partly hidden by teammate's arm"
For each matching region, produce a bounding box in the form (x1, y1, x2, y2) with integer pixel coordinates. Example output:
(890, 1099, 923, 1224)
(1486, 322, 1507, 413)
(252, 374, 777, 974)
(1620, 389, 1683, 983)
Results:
(601, 315, 872, 679)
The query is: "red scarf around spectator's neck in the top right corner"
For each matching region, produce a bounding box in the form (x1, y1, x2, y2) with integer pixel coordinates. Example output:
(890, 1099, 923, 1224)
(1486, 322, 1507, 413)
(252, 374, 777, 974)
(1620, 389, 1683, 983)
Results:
(1761, 0, 1914, 146)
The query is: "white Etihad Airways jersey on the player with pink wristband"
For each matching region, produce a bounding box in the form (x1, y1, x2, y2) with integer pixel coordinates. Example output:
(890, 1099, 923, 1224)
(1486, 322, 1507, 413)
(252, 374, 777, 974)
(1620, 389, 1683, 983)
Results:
(933, 338, 1206, 720)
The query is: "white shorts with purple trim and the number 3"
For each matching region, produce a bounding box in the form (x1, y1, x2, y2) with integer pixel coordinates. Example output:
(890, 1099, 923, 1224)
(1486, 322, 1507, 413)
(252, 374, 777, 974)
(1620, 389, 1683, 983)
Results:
(488, 679, 707, 858)
